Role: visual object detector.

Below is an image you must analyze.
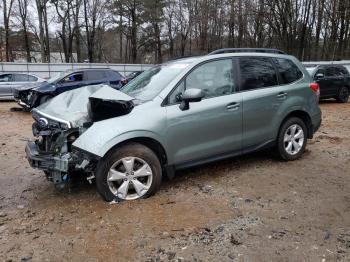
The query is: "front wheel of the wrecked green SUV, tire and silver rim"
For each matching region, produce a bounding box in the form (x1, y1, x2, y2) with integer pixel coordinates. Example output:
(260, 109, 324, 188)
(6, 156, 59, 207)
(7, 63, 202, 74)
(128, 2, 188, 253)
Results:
(95, 143, 162, 202)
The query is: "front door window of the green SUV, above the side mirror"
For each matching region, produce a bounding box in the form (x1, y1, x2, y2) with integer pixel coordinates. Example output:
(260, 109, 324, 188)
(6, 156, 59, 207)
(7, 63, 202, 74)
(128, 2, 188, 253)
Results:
(169, 58, 235, 104)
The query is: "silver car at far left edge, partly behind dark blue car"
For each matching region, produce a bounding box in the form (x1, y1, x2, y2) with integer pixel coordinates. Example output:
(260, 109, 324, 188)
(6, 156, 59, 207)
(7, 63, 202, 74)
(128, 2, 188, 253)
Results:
(0, 73, 45, 100)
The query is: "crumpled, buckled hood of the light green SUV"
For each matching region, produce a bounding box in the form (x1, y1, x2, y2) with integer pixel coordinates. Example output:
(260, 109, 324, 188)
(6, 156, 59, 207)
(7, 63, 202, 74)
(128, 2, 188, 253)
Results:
(33, 85, 134, 127)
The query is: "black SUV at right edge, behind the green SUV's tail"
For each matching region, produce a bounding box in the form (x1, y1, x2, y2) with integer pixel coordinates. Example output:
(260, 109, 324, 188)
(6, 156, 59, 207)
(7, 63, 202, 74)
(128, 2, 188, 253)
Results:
(311, 65, 350, 103)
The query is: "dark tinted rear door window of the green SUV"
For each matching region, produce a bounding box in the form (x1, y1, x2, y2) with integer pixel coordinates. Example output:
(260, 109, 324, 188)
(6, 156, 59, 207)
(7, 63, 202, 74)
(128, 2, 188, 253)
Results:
(239, 57, 278, 90)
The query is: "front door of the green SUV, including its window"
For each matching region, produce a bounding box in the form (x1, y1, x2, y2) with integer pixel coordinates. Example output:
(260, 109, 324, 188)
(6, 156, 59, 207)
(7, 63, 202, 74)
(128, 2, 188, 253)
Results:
(166, 58, 242, 164)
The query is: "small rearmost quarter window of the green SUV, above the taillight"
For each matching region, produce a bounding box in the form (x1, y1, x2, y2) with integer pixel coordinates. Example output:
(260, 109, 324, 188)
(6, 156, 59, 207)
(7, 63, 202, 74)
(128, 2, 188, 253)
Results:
(276, 58, 303, 85)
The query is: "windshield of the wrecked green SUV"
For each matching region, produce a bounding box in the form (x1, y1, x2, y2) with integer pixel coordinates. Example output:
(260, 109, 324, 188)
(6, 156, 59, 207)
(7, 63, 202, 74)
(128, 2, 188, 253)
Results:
(120, 64, 188, 100)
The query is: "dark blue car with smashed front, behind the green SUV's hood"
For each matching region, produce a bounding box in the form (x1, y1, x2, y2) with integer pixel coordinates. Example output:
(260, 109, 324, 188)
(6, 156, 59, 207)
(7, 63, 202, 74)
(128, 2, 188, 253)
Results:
(13, 68, 127, 109)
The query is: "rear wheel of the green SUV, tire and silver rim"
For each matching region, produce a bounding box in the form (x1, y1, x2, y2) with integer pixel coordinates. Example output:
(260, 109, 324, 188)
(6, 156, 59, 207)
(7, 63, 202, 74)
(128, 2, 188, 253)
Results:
(277, 117, 307, 161)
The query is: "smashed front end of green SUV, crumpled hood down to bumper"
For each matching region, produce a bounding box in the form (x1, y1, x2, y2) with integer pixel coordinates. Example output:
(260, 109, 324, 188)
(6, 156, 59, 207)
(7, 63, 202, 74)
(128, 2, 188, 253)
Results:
(25, 85, 134, 186)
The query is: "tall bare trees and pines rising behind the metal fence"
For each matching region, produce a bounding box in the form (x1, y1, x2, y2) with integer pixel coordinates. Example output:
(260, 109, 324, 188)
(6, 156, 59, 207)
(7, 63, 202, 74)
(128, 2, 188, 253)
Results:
(0, 0, 350, 63)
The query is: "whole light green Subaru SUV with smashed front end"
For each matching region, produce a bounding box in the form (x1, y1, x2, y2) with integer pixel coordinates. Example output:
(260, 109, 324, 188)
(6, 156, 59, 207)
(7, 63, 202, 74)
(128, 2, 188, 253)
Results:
(26, 49, 321, 201)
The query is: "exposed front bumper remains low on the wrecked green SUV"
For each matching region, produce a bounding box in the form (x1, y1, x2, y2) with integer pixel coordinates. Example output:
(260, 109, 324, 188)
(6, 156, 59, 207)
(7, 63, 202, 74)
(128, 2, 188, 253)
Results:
(25, 142, 71, 173)
